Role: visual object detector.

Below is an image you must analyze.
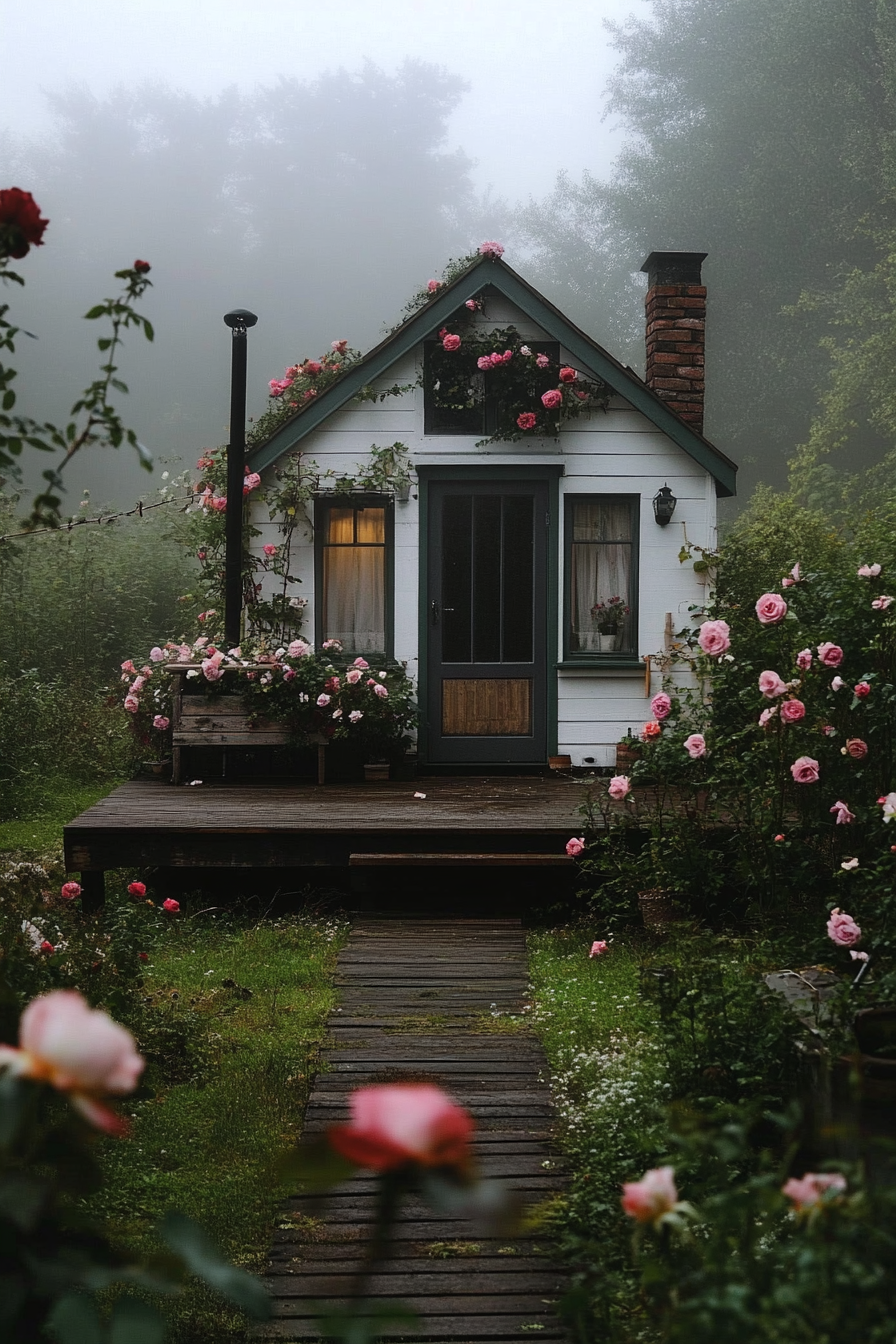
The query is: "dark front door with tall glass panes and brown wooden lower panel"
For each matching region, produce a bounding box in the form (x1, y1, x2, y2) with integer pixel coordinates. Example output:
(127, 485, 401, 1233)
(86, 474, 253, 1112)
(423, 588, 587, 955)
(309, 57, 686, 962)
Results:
(424, 480, 548, 766)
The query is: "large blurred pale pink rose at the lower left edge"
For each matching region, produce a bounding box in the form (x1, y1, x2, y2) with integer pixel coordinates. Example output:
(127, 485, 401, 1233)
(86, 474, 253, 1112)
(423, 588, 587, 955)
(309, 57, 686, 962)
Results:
(0, 989, 144, 1134)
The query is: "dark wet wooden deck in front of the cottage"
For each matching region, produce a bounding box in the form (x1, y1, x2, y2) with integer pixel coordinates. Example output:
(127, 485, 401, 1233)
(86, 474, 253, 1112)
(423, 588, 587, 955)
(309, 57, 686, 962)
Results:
(64, 775, 584, 875)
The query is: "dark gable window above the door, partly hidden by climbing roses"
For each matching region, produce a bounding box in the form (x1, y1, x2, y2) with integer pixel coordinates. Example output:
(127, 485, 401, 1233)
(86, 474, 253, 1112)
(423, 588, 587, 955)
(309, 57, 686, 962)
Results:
(423, 340, 560, 438)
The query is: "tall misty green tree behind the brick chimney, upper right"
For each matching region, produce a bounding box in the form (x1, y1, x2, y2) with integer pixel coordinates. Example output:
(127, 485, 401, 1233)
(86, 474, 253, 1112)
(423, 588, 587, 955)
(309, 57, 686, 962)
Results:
(525, 0, 893, 505)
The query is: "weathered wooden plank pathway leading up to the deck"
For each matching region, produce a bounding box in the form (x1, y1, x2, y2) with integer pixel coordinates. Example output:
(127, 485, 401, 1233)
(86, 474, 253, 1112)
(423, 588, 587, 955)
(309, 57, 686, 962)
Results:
(254, 919, 564, 1344)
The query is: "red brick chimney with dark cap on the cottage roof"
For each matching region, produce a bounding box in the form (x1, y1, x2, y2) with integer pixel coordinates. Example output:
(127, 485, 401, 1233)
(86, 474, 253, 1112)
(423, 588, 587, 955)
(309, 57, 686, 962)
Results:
(641, 253, 707, 434)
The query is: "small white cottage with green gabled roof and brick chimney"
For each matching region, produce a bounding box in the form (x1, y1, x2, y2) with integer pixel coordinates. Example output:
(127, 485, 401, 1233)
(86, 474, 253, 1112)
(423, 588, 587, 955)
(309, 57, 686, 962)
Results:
(250, 253, 736, 773)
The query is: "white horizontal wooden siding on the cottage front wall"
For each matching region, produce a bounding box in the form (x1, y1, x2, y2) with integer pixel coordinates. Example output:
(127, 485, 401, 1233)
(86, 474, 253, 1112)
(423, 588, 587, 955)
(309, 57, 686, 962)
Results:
(253, 306, 716, 766)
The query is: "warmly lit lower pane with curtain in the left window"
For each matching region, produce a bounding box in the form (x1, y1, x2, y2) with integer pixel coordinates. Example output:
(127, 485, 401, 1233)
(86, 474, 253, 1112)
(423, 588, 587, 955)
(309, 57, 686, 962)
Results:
(321, 545, 386, 653)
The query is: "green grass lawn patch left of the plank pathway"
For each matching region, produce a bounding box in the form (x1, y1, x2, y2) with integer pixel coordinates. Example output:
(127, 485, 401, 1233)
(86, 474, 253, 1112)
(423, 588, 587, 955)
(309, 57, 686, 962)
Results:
(91, 915, 344, 1344)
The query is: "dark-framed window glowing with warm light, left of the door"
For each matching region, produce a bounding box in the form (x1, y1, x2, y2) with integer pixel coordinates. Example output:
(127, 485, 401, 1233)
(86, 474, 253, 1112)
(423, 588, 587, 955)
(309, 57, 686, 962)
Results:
(314, 496, 392, 655)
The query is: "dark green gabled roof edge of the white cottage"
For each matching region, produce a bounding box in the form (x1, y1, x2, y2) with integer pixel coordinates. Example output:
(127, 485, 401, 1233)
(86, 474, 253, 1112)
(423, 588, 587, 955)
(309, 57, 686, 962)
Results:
(249, 249, 737, 495)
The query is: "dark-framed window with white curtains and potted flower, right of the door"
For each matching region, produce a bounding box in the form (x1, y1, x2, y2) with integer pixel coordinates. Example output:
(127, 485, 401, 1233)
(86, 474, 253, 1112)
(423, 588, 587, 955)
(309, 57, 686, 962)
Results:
(564, 495, 639, 661)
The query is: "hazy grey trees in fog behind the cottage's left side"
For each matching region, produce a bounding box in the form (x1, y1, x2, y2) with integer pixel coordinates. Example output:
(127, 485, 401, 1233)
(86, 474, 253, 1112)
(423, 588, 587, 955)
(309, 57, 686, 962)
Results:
(7, 60, 494, 505)
